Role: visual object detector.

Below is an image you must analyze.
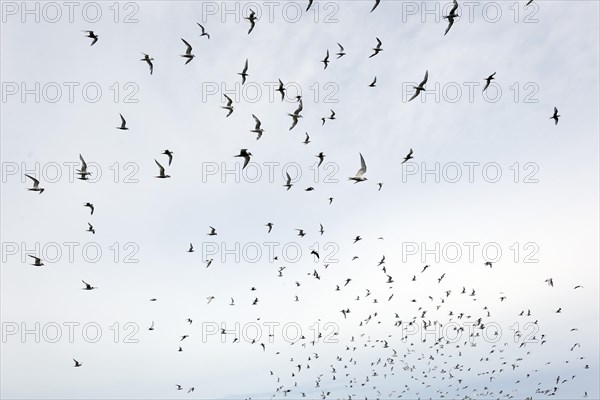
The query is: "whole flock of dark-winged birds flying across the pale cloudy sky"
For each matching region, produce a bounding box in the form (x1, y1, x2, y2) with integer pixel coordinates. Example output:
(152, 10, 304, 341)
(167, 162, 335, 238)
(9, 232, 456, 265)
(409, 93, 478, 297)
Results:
(14, 0, 590, 399)
